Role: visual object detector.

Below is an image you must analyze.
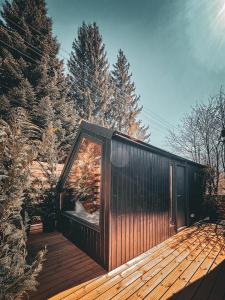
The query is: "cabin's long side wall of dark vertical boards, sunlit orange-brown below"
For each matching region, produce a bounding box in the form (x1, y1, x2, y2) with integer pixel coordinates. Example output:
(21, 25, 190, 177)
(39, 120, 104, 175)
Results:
(109, 137, 205, 269)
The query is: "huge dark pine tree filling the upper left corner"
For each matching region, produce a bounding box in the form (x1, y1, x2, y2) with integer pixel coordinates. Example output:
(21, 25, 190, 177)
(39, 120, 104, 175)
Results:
(0, 0, 77, 159)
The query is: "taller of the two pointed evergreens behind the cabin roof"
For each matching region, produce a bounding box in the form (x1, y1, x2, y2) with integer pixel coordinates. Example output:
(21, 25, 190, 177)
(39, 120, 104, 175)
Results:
(68, 23, 112, 127)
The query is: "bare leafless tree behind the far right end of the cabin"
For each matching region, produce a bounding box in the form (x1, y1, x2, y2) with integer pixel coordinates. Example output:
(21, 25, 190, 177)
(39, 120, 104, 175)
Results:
(168, 88, 225, 194)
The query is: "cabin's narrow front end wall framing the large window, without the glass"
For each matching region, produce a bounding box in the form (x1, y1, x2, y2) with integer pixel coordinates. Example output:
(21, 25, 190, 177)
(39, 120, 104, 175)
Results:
(58, 130, 111, 269)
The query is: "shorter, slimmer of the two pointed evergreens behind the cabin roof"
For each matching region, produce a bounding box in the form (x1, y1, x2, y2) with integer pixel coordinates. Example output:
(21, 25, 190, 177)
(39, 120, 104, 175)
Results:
(112, 50, 150, 141)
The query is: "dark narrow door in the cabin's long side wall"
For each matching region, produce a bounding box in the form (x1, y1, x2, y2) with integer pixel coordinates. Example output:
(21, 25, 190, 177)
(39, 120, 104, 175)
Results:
(176, 165, 186, 230)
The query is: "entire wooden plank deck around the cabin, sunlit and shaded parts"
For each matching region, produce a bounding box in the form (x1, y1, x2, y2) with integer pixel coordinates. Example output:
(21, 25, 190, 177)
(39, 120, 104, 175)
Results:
(30, 224, 225, 300)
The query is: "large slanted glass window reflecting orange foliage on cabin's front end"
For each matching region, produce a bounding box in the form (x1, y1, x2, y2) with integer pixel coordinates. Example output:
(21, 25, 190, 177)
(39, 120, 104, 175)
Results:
(61, 138, 102, 225)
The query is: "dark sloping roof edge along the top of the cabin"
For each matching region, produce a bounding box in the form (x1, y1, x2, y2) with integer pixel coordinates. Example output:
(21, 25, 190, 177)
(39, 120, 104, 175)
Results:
(80, 121, 205, 167)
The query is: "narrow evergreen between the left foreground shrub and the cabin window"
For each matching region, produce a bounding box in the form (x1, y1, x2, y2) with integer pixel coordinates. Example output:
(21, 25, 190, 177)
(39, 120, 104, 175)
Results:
(26, 123, 60, 231)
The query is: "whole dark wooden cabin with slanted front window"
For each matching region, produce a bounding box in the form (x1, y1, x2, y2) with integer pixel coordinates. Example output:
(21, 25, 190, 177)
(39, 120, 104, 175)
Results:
(57, 122, 204, 270)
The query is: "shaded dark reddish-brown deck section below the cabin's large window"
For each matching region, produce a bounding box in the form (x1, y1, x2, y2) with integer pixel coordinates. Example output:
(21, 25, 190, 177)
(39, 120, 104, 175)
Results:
(28, 226, 106, 300)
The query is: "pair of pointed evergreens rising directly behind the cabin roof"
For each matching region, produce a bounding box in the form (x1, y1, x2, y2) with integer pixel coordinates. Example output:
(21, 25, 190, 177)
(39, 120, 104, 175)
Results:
(68, 23, 150, 141)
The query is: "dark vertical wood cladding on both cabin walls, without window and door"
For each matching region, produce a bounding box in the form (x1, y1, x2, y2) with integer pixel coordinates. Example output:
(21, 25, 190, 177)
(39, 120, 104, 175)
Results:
(58, 122, 203, 270)
